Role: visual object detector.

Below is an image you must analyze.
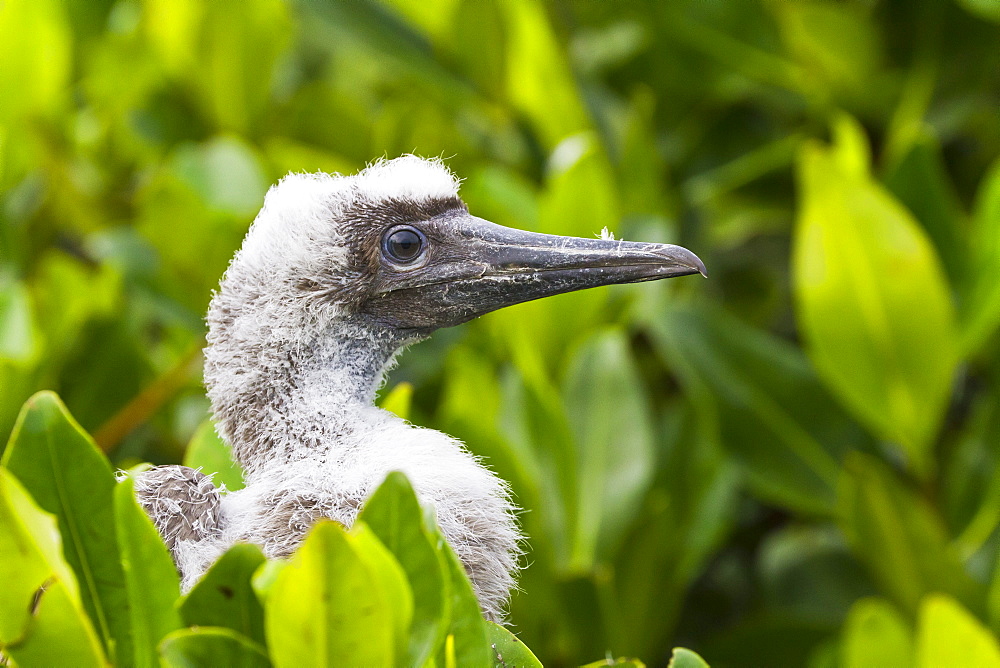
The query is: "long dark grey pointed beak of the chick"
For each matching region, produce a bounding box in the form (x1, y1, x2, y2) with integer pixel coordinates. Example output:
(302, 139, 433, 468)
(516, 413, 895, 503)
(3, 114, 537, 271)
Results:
(372, 212, 707, 329)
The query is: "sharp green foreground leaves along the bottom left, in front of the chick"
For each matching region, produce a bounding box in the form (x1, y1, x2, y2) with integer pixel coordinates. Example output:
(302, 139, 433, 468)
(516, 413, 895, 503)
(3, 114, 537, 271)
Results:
(0, 393, 705, 667)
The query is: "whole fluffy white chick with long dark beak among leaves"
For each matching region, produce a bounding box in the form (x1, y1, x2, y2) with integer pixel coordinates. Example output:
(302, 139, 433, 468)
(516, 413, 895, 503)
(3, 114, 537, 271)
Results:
(136, 156, 704, 621)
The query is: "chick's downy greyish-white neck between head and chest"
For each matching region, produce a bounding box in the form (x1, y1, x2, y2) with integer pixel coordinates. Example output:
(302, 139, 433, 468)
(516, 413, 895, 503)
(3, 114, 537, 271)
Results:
(205, 310, 408, 480)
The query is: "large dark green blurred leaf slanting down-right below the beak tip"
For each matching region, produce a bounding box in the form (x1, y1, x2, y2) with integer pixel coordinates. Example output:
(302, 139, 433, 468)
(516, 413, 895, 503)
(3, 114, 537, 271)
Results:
(649, 306, 866, 514)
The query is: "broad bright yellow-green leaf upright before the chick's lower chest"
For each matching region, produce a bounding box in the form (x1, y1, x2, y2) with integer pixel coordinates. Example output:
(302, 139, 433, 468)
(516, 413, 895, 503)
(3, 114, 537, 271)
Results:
(264, 521, 412, 666)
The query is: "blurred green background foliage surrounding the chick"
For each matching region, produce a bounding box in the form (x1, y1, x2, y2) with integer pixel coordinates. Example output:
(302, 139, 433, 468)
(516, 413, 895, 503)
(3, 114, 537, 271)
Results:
(0, 0, 1000, 666)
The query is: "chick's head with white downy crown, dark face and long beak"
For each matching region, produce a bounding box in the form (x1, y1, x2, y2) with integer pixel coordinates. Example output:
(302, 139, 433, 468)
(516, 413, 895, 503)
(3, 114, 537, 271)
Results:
(230, 156, 705, 338)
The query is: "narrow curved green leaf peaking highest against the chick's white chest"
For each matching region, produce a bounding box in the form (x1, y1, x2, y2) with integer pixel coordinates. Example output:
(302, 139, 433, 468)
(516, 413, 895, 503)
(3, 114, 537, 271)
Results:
(358, 471, 451, 665)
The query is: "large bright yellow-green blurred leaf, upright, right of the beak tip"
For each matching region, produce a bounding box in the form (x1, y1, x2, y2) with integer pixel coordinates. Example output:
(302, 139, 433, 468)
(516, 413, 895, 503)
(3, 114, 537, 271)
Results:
(793, 121, 957, 476)
